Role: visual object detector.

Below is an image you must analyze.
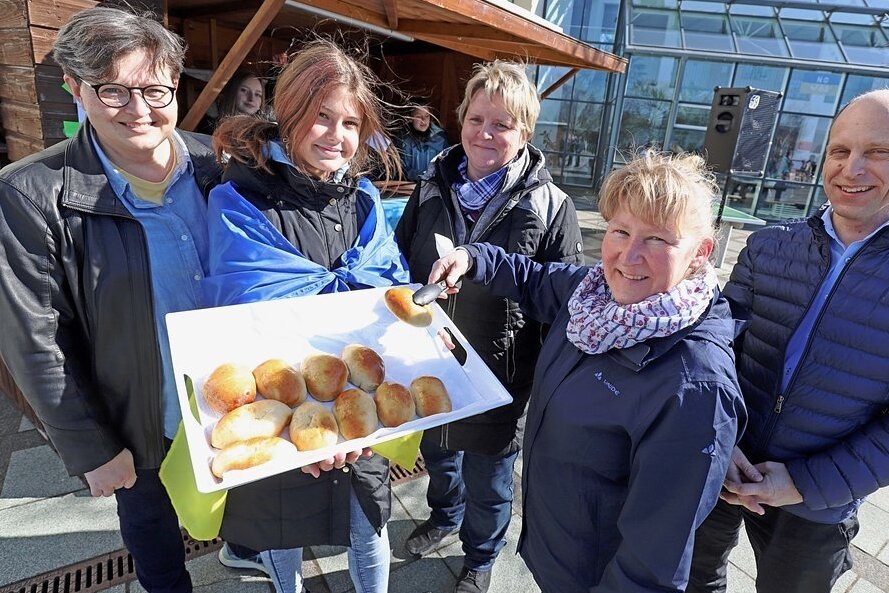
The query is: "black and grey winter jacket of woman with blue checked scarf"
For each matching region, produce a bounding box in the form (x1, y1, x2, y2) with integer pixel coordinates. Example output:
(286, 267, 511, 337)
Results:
(395, 144, 583, 455)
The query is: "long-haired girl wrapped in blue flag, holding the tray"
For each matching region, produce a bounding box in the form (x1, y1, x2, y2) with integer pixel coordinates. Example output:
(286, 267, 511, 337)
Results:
(205, 40, 408, 593)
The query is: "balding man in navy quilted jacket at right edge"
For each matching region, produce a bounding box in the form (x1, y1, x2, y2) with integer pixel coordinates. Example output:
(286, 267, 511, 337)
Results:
(688, 90, 889, 593)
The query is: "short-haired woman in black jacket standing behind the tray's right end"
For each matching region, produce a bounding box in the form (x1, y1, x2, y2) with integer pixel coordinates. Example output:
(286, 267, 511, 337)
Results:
(395, 61, 583, 593)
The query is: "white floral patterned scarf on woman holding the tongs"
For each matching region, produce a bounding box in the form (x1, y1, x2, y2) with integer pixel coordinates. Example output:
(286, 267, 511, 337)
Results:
(566, 262, 717, 354)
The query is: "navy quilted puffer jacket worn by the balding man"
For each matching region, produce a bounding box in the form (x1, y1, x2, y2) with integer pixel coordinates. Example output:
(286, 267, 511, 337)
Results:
(725, 213, 889, 523)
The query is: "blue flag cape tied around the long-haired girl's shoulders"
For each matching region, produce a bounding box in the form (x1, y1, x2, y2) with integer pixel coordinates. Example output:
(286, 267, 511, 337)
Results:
(204, 177, 410, 306)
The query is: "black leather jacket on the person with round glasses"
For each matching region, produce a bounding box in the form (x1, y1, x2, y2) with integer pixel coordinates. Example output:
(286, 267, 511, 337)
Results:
(0, 124, 220, 475)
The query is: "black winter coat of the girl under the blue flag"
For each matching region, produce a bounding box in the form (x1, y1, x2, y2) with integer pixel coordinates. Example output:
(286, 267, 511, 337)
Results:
(212, 160, 391, 550)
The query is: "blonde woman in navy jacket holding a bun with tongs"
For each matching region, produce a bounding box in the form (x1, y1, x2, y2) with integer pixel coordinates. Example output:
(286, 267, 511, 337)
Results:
(428, 151, 746, 593)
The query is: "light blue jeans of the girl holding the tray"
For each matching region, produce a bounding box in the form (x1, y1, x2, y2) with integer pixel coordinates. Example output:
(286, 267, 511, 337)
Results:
(229, 490, 389, 593)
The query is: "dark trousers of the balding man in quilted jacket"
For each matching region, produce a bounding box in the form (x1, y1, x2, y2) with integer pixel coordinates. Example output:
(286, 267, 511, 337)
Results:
(686, 500, 858, 593)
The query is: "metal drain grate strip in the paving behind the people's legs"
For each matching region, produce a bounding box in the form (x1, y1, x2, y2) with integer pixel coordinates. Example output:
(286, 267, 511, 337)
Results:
(0, 457, 426, 593)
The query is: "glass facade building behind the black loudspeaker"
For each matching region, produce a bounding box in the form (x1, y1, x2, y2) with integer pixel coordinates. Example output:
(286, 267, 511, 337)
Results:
(533, 0, 889, 221)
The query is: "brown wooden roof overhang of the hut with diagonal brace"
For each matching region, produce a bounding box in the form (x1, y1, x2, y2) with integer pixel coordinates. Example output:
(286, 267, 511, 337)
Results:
(179, 0, 627, 129)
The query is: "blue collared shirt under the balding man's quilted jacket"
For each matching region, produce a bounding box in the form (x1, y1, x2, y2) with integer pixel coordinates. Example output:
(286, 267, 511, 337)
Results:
(781, 206, 889, 394)
